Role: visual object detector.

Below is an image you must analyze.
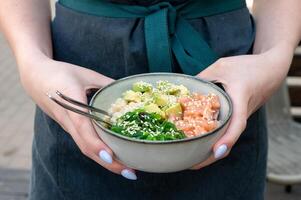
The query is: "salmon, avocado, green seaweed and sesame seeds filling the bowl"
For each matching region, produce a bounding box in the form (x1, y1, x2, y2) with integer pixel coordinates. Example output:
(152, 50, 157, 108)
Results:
(109, 80, 220, 141)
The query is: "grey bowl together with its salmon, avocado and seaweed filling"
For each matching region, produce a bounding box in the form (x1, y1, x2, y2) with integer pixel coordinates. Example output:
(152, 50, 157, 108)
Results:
(90, 73, 232, 173)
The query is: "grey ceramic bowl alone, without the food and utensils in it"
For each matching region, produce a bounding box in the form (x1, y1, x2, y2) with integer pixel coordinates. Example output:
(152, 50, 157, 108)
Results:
(90, 73, 232, 173)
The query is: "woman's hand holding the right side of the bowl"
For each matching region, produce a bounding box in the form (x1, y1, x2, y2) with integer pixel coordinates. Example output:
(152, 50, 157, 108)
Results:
(192, 43, 293, 169)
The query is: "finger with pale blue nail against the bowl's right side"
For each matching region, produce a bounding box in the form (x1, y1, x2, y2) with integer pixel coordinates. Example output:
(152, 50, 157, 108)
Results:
(213, 91, 248, 159)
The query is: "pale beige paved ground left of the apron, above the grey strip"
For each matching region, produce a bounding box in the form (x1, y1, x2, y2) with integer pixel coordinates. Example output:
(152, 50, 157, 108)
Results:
(0, 35, 34, 169)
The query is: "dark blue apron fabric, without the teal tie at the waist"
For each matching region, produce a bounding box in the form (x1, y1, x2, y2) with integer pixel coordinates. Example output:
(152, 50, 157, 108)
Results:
(30, 0, 267, 200)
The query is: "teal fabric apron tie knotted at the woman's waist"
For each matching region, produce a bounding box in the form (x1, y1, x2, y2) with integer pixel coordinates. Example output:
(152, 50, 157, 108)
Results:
(59, 0, 246, 75)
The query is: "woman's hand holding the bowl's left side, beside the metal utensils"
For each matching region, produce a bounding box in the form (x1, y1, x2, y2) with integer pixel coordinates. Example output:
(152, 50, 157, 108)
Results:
(19, 55, 137, 180)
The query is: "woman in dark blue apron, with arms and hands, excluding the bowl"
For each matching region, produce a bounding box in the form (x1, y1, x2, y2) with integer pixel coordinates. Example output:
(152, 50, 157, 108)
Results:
(0, 0, 301, 200)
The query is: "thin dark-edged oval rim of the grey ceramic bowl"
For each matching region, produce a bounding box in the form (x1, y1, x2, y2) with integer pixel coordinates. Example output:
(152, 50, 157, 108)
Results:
(89, 72, 233, 144)
